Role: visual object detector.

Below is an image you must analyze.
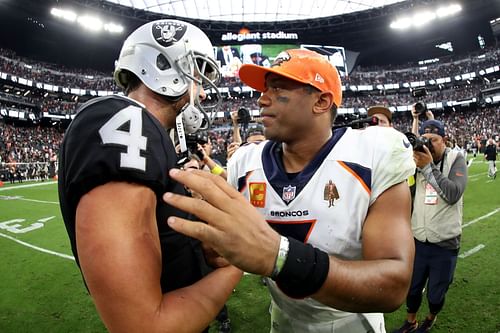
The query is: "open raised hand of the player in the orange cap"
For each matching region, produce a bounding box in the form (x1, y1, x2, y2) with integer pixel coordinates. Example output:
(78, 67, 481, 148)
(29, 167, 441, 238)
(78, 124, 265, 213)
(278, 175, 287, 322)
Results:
(163, 169, 280, 276)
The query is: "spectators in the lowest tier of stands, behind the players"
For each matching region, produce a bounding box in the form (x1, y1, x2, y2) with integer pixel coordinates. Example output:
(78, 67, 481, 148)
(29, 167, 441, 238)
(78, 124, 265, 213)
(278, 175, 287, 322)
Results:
(0, 107, 500, 174)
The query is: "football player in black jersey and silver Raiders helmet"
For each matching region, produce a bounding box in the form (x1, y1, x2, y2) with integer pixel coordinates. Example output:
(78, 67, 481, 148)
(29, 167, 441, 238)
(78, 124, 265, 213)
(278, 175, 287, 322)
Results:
(59, 20, 241, 332)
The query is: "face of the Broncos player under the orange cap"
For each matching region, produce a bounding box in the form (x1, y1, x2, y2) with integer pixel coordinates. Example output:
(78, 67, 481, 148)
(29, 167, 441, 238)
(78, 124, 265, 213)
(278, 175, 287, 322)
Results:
(258, 73, 319, 143)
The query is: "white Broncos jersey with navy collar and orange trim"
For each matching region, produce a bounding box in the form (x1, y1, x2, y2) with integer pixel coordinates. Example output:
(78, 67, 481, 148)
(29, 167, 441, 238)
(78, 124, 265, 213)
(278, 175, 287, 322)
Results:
(228, 126, 415, 330)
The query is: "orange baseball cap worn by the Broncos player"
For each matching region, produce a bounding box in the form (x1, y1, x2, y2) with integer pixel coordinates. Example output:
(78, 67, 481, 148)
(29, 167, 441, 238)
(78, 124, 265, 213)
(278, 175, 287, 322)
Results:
(239, 49, 342, 107)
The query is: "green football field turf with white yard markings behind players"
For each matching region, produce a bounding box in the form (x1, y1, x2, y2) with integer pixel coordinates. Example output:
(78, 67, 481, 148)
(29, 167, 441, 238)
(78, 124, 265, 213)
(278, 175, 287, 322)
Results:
(0, 160, 500, 333)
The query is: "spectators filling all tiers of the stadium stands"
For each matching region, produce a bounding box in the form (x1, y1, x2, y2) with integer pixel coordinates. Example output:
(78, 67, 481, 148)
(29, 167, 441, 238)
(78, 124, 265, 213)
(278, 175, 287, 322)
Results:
(0, 48, 500, 174)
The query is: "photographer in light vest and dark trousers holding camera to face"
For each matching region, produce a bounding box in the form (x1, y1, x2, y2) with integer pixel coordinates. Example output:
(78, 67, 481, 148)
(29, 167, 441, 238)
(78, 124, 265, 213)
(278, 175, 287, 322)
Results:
(396, 119, 467, 332)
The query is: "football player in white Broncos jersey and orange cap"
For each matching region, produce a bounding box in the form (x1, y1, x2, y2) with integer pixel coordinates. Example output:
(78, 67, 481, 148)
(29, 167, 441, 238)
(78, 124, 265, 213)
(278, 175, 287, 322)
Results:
(164, 49, 415, 333)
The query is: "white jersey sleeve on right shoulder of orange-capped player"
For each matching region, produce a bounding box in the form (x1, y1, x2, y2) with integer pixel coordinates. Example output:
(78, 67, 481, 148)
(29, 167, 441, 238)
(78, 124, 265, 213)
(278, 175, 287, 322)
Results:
(366, 126, 416, 205)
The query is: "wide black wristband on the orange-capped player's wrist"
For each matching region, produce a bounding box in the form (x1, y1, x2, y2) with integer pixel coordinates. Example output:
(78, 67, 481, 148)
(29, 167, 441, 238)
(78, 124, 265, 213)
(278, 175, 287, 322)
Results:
(275, 238, 330, 298)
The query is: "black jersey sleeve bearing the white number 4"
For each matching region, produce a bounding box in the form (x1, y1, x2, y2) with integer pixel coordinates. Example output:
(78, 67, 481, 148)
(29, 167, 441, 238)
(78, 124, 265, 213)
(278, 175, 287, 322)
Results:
(62, 98, 176, 201)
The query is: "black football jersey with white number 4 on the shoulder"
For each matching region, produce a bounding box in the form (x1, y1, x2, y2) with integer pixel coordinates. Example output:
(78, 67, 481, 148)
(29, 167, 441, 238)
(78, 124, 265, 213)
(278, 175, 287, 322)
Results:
(58, 96, 205, 292)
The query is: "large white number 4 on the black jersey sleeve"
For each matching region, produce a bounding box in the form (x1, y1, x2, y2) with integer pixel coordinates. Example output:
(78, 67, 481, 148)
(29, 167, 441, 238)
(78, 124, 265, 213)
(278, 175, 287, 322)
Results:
(99, 105, 148, 171)
